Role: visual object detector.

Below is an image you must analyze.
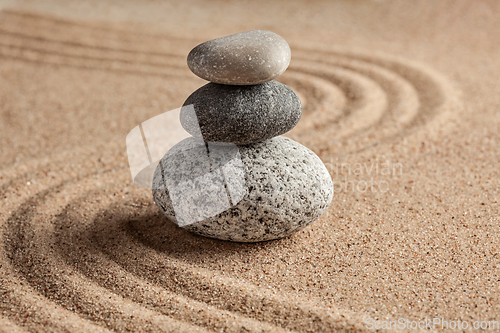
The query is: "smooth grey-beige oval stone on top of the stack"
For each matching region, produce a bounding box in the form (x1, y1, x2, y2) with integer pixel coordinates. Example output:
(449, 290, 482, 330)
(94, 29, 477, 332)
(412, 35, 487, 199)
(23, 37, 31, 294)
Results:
(187, 30, 291, 85)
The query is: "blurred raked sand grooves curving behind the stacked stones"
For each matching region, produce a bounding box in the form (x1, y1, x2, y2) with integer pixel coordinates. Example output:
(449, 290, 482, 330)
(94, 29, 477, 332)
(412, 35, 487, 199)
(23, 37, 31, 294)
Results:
(0, 12, 457, 154)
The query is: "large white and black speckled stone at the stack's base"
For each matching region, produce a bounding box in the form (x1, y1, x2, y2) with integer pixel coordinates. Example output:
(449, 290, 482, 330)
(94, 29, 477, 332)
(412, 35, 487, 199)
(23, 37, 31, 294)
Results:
(153, 137, 333, 242)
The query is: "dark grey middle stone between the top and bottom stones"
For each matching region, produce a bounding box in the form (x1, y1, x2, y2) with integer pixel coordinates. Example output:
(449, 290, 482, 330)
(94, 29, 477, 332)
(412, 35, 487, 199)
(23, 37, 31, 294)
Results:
(180, 81, 302, 145)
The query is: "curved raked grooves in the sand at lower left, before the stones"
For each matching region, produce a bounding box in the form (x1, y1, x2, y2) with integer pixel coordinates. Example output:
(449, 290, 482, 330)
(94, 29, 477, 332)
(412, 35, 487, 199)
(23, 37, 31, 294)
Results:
(0, 148, 372, 332)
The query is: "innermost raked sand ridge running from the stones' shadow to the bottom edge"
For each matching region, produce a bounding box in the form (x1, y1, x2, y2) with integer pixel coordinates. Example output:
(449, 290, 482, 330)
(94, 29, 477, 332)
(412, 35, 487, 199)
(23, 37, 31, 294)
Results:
(89, 205, 364, 332)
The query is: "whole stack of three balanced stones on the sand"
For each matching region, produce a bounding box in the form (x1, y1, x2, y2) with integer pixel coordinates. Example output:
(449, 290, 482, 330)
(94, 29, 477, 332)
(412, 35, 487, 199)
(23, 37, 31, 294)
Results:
(153, 30, 333, 242)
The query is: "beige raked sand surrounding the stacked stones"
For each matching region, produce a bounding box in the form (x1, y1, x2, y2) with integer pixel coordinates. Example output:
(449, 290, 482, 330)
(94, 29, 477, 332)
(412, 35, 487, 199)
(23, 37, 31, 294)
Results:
(0, 0, 500, 332)
